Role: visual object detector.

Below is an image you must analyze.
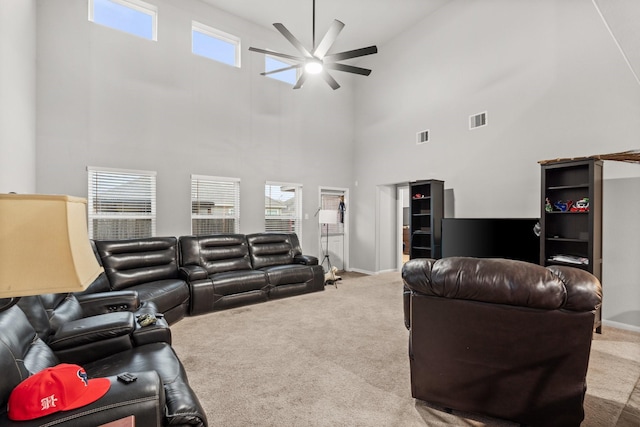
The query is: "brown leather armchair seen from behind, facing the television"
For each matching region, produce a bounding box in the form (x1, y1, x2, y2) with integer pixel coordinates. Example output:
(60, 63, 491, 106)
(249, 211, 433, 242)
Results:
(402, 258, 602, 426)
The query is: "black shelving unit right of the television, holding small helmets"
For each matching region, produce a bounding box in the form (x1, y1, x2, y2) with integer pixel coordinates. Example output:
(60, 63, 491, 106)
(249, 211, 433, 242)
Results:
(540, 159, 603, 333)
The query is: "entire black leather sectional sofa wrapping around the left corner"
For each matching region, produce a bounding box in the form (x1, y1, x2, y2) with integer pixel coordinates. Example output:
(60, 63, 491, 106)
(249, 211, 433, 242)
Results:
(0, 233, 324, 427)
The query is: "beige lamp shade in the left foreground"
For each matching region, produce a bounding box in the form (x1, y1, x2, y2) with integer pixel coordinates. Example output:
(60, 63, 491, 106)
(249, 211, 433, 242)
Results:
(0, 194, 103, 298)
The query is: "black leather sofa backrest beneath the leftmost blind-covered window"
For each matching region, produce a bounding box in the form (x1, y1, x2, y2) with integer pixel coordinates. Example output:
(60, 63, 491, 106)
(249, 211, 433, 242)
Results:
(95, 237, 178, 290)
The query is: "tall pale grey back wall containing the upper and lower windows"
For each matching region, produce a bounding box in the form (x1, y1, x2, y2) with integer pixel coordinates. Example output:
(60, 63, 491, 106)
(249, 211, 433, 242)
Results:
(37, 0, 354, 254)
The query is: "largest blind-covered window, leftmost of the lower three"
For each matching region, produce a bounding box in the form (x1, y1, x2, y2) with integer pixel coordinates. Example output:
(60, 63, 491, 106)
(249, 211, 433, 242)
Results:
(87, 167, 156, 240)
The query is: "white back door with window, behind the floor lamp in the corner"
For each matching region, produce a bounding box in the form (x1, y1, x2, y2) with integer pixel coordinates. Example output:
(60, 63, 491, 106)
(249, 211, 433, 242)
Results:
(318, 187, 349, 271)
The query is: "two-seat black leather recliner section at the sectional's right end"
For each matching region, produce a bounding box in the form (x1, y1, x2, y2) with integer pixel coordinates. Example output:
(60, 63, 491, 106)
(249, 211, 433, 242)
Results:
(179, 233, 324, 315)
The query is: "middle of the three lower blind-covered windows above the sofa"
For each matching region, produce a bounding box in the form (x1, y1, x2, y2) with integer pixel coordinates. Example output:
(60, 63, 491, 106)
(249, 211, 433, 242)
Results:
(191, 175, 240, 236)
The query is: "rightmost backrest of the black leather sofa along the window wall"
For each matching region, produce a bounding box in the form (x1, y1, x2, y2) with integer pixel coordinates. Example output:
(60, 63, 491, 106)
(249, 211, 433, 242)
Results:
(247, 233, 299, 269)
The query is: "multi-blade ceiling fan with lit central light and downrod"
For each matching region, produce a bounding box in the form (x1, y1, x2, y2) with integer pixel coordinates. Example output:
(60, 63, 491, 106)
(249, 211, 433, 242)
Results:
(249, 0, 378, 90)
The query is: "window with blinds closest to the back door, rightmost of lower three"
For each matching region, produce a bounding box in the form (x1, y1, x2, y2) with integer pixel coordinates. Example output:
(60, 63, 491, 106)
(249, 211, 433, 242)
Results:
(264, 182, 302, 238)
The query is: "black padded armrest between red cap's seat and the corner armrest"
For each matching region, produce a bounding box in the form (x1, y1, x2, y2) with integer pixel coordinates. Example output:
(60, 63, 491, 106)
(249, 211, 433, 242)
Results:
(48, 312, 135, 352)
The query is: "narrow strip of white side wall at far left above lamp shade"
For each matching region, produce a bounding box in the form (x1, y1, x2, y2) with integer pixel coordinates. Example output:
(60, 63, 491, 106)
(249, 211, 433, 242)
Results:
(0, 0, 36, 193)
